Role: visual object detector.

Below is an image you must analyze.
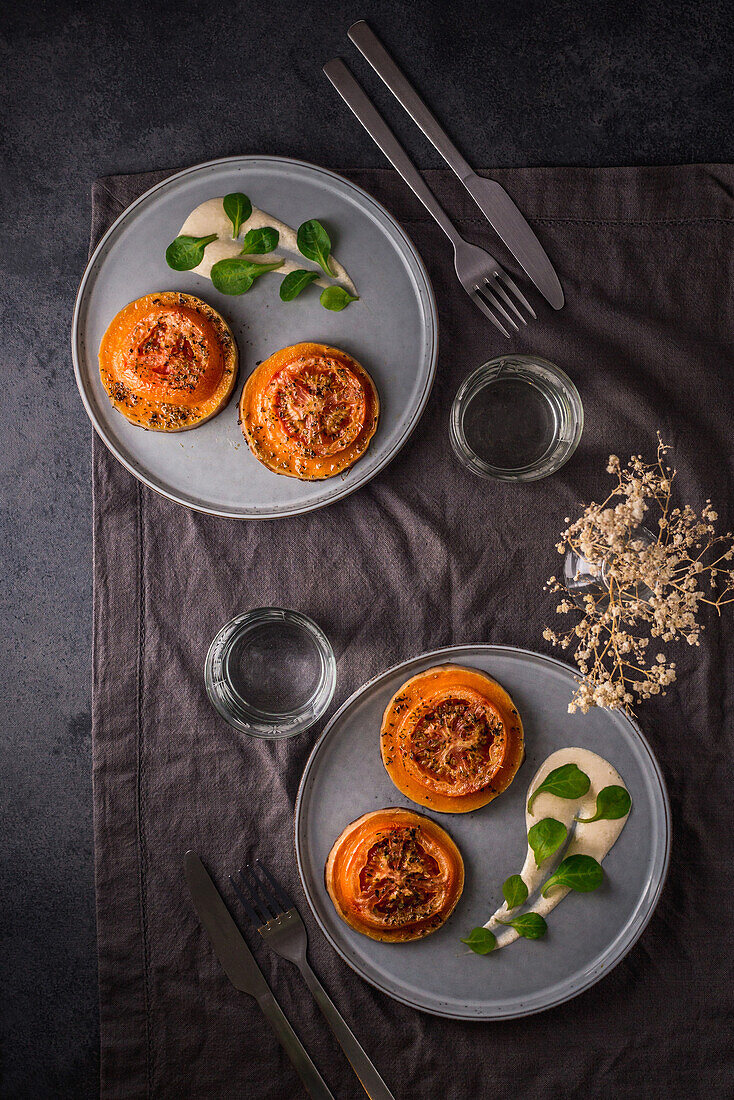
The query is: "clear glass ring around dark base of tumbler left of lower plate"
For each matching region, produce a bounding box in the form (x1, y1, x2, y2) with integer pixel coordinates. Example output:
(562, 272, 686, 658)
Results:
(204, 607, 337, 740)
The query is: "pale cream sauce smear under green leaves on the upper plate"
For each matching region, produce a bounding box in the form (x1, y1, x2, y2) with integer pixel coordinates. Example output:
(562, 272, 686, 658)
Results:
(178, 198, 357, 295)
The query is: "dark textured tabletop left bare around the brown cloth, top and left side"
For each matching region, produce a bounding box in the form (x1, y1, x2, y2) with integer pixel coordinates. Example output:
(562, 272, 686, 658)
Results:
(0, 0, 734, 1100)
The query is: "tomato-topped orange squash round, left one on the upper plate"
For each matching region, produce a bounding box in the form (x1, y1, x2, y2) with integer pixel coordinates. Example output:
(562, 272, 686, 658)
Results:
(99, 290, 238, 431)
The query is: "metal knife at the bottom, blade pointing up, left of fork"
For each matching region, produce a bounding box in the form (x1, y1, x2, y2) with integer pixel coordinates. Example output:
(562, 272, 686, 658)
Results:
(184, 851, 335, 1100)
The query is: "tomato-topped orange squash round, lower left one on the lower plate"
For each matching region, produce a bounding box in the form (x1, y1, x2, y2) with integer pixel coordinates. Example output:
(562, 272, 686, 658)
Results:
(326, 809, 464, 943)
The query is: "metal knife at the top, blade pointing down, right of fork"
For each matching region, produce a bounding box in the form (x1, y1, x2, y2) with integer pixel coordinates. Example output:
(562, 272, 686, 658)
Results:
(347, 19, 563, 309)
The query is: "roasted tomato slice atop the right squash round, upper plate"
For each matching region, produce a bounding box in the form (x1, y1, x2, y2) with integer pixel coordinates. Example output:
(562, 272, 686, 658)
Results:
(269, 356, 368, 457)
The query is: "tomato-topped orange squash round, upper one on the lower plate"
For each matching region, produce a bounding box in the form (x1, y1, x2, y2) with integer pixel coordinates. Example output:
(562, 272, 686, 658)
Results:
(380, 664, 525, 814)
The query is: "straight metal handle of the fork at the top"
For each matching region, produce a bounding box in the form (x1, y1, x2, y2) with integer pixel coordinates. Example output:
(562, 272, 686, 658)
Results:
(324, 57, 461, 248)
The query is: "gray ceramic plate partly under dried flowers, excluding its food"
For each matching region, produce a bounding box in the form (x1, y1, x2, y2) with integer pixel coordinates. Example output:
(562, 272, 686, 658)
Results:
(295, 646, 670, 1020)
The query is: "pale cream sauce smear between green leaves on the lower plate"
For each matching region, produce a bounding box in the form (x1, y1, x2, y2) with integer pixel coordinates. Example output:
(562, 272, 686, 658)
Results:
(484, 749, 629, 948)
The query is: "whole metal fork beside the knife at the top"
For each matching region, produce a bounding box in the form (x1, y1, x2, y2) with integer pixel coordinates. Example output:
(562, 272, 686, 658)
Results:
(324, 58, 536, 337)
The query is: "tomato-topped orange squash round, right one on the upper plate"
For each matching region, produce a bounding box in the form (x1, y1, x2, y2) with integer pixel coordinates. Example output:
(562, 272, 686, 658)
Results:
(240, 343, 380, 481)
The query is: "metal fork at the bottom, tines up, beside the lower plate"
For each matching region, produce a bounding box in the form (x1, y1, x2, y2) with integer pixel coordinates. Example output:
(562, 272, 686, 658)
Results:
(234, 859, 395, 1100)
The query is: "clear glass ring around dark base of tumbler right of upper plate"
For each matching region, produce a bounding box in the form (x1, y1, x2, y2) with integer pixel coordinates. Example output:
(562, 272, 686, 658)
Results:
(449, 354, 584, 482)
